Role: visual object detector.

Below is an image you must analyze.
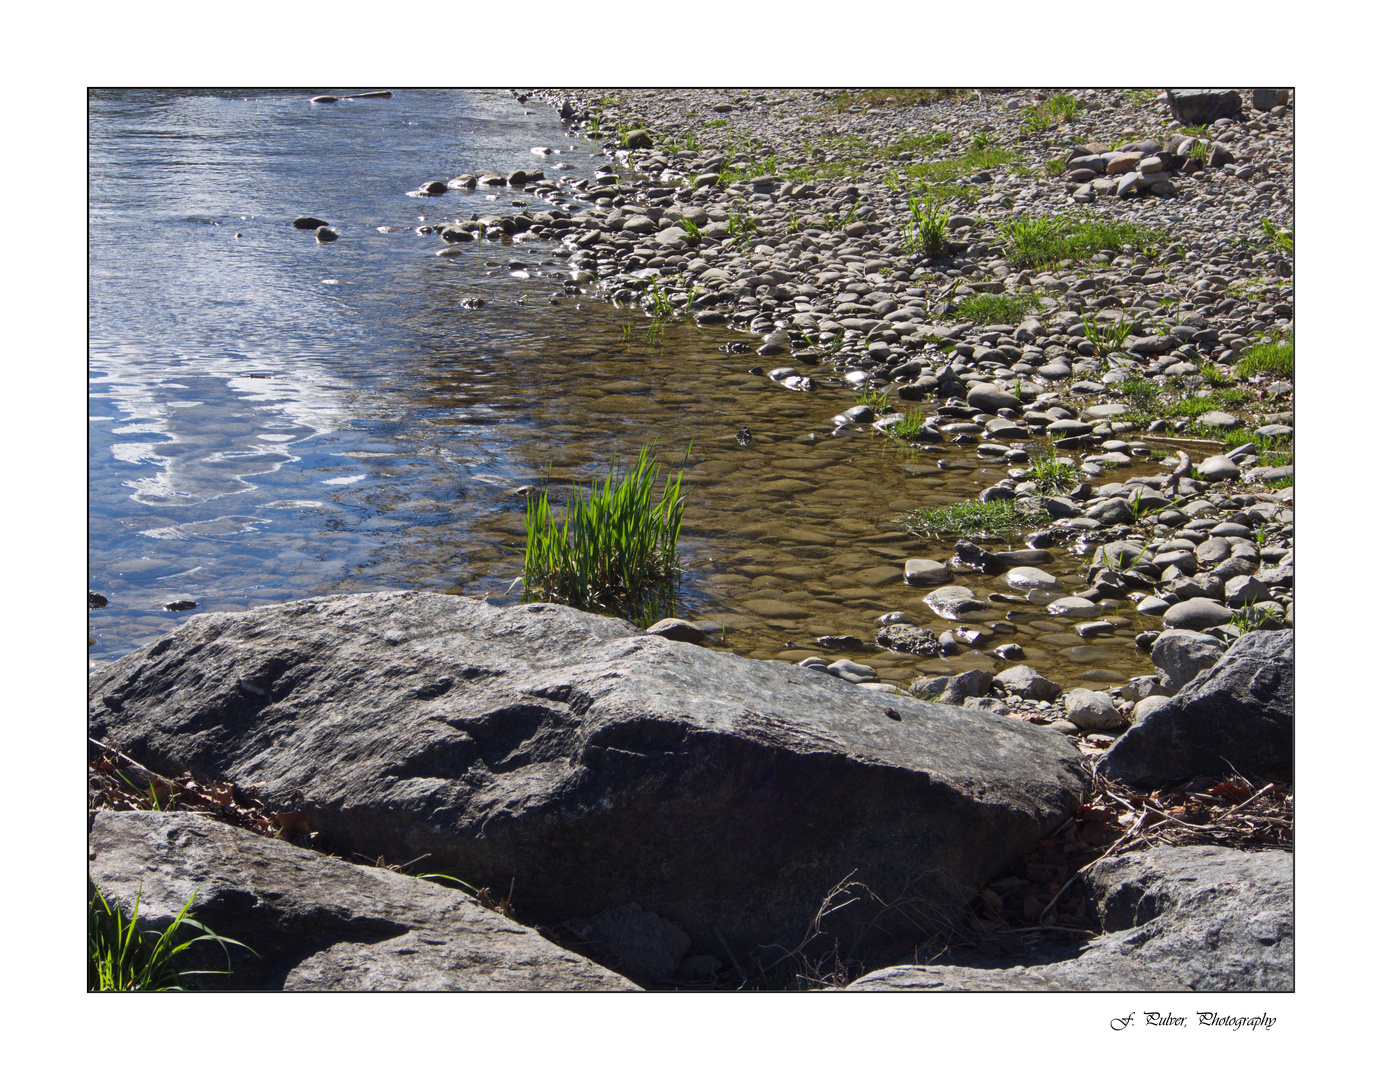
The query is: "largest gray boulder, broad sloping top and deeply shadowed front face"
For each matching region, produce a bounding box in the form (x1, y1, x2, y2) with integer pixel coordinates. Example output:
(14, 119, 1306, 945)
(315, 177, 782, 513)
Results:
(90, 592, 1086, 960)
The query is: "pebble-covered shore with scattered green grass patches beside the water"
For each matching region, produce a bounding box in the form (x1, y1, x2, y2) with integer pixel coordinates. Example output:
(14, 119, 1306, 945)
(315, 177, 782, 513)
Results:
(520, 90, 1294, 730)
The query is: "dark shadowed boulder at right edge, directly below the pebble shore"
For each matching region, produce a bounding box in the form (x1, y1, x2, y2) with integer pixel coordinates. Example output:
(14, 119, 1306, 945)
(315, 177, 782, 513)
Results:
(1097, 631, 1295, 787)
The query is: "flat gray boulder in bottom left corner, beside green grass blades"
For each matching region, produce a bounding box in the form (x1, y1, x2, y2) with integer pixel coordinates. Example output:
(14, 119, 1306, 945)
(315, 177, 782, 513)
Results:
(90, 810, 638, 990)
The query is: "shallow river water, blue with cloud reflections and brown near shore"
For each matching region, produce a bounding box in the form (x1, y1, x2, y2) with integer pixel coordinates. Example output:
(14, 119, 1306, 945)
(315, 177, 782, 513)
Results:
(88, 90, 1151, 686)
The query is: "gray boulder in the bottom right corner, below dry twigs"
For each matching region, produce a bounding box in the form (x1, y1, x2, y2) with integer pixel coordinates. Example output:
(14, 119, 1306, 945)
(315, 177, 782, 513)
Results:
(849, 846, 1295, 991)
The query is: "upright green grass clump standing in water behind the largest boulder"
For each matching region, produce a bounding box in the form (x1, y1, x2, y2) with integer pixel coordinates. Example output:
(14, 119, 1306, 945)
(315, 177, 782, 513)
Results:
(522, 445, 691, 622)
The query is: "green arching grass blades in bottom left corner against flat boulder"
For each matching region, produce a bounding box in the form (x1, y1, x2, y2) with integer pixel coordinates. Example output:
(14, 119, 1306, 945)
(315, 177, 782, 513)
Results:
(87, 884, 248, 991)
